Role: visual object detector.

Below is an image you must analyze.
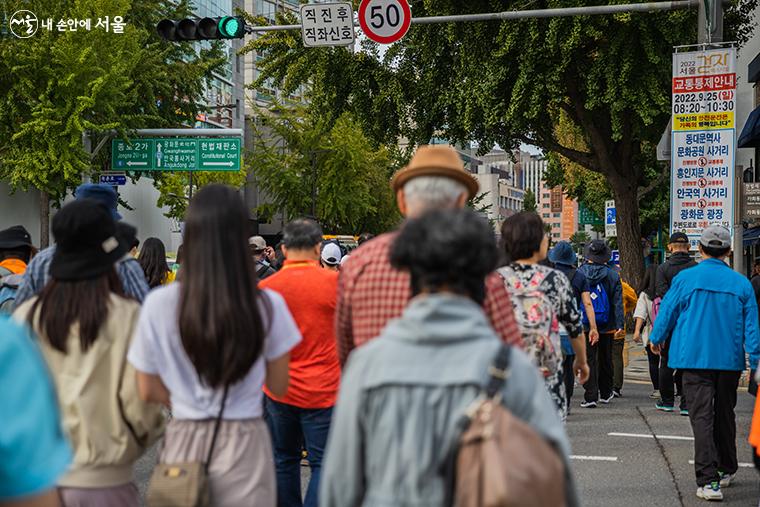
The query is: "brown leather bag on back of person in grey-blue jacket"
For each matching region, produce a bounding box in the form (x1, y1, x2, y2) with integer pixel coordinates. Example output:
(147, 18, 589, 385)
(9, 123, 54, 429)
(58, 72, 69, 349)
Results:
(444, 345, 567, 507)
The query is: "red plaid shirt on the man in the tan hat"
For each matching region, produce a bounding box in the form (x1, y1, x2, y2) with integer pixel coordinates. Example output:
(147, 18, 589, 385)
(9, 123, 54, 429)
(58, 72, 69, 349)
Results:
(335, 232, 522, 365)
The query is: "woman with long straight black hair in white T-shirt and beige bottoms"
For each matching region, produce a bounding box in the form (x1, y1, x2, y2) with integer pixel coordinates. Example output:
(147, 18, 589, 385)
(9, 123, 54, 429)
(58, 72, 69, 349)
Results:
(128, 185, 301, 507)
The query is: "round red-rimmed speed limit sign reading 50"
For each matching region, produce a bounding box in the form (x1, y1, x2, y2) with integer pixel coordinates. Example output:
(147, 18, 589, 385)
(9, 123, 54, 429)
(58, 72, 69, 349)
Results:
(359, 0, 412, 44)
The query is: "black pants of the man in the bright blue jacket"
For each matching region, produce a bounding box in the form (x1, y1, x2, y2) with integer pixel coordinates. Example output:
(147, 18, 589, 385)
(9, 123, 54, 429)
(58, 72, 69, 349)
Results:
(683, 370, 741, 486)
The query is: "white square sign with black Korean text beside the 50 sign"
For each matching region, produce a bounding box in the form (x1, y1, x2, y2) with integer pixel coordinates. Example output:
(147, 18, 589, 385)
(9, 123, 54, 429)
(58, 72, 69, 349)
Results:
(301, 2, 354, 48)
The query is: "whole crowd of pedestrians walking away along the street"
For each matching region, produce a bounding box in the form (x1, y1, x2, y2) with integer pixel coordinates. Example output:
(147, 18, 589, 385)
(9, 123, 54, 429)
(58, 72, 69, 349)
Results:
(0, 146, 760, 507)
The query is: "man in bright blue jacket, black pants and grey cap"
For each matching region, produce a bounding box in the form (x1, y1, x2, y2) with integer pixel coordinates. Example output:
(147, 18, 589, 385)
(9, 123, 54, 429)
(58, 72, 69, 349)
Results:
(650, 226, 760, 501)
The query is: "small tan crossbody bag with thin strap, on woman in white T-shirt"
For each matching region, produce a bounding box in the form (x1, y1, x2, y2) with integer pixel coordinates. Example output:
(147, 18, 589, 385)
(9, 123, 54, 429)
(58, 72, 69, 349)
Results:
(146, 385, 229, 507)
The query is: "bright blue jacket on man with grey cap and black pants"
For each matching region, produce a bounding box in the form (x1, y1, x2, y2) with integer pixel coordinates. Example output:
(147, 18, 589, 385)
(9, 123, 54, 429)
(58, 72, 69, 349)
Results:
(650, 259, 760, 371)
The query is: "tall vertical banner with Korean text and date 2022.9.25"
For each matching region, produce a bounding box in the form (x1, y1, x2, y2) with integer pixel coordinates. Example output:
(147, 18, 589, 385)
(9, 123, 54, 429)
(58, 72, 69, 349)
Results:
(670, 48, 736, 250)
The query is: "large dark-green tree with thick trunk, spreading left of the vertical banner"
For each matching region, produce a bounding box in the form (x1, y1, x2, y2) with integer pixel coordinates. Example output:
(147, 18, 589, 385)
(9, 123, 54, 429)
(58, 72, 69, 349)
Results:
(251, 0, 756, 284)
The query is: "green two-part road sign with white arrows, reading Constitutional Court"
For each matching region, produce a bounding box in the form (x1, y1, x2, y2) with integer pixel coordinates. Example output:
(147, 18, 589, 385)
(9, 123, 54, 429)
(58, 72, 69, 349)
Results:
(111, 137, 240, 171)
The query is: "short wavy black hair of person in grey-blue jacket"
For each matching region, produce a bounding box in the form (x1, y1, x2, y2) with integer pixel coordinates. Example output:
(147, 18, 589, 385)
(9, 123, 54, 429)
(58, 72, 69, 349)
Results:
(391, 209, 498, 304)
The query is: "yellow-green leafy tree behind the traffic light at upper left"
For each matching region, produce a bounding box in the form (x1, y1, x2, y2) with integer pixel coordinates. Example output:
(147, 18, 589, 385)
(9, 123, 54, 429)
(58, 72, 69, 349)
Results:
(0, 0, 224, 244)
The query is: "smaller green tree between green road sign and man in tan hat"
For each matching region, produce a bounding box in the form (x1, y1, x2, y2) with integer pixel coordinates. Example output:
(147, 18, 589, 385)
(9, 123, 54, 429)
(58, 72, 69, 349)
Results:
(247, 107, 400, 234)
